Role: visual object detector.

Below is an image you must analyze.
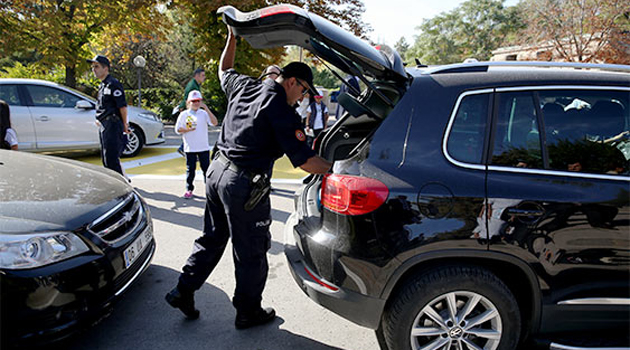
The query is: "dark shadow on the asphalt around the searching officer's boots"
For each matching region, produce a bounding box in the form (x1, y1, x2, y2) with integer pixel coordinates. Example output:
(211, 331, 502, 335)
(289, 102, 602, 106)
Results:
(42, 265, 346, 350)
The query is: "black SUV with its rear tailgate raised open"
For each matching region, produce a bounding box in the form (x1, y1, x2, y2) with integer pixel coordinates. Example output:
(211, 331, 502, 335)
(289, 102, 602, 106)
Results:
(222, 5, 630, 350)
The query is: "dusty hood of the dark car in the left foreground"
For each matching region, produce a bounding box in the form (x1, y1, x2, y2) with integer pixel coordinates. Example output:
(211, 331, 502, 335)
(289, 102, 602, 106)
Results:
(0, 150, 132, 233)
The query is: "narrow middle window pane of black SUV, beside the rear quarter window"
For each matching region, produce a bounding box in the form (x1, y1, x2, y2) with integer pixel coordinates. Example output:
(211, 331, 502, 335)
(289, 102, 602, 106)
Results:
(490, 91, 543, 169)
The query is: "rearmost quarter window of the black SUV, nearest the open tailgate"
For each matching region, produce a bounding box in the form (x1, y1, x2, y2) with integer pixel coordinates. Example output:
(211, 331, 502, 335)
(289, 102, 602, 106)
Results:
(446, 94, 490, 164)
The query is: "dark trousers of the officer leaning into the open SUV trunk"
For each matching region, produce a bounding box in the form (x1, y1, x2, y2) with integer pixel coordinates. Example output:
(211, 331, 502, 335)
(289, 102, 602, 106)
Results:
(179, 160, 271, 311)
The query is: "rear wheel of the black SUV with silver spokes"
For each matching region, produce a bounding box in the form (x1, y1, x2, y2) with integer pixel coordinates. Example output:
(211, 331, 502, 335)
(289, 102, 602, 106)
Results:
(381, 266, 521, 350)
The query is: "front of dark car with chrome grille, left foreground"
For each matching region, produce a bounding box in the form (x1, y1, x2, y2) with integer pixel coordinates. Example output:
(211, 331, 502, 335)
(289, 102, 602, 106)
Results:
(0, 150, 155, 349)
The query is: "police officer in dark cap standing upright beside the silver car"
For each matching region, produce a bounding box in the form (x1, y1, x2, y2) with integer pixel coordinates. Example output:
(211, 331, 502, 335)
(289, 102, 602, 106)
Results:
(86, 55, 129, 176)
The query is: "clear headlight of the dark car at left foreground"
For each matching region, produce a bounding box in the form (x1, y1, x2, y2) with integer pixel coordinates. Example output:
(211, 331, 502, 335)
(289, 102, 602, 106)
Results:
(0, 232, 89, 270)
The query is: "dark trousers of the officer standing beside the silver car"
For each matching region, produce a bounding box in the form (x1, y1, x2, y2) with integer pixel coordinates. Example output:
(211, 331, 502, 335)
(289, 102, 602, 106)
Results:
(100, 115, 127, 175)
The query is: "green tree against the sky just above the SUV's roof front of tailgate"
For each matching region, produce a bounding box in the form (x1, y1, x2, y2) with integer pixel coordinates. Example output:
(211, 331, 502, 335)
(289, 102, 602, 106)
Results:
(407, 0, 523, 64)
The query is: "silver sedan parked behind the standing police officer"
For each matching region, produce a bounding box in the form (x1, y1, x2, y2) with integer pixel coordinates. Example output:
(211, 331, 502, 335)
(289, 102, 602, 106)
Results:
(0, 79, 165, 157)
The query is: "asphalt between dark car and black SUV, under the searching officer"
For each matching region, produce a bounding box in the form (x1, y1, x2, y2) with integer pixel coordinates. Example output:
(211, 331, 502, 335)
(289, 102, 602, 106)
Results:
(46, 178, 379, 350)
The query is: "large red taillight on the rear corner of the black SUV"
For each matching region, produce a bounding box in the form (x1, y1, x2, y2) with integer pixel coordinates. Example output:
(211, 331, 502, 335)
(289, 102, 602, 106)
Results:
(322, 174, 389, 215)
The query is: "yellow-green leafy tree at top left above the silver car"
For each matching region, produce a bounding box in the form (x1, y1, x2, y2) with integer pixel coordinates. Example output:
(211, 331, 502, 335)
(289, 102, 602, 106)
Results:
(0, 0, 167, 87)
